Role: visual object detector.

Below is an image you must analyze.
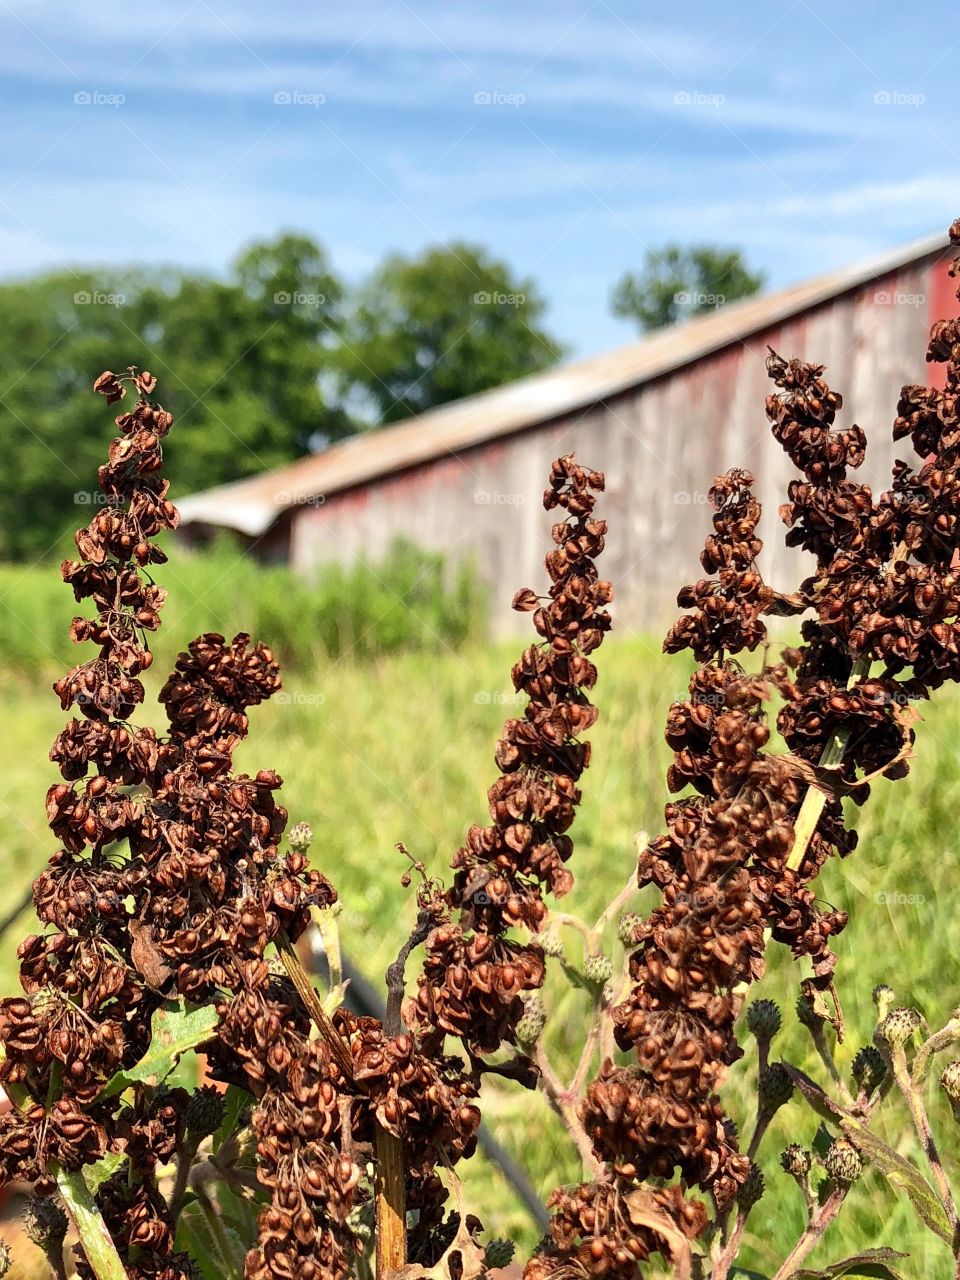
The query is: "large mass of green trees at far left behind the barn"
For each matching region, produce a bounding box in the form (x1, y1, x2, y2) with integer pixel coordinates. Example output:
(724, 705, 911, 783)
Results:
(0, 234, 352, 559)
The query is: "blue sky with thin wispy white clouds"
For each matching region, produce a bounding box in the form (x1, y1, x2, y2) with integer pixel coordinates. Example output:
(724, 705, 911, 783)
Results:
(0, 0, 960, 353)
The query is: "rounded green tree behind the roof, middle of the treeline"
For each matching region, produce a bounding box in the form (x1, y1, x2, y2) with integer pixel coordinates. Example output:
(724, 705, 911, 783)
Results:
(339, 242, 562, 422)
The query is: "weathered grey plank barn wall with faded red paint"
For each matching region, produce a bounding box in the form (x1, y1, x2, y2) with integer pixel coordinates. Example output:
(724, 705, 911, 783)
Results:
(291, 261, 955, 632)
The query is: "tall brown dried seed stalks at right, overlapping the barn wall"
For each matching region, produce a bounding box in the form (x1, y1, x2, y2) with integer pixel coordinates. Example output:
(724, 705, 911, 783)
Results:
(527, 230, 960, 1280)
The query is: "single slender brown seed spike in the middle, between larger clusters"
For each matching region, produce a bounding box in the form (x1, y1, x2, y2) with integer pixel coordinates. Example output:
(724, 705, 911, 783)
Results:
(411, 456, 613, 1053)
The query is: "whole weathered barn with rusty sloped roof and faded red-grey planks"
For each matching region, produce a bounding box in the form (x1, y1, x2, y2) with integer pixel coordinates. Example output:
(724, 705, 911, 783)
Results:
(180, 237, 957, 630)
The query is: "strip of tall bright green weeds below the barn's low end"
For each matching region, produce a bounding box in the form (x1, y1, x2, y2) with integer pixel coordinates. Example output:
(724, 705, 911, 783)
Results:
(0, 536, 485, 680)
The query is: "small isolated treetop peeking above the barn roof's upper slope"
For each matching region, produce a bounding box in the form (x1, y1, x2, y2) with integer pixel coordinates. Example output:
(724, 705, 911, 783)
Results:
(611, 244, 764, 332)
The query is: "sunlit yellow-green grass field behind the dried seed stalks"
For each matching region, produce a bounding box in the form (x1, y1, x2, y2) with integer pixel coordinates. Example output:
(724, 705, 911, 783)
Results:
(0, 640, 960, 1276)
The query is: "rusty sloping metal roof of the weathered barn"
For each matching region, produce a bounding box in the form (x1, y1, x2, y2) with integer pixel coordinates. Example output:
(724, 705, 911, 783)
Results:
(178, 227, 947, 538)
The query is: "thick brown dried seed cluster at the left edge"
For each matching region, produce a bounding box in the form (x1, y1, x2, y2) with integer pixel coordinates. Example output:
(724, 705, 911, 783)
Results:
(0, 370, 358, 1280)
